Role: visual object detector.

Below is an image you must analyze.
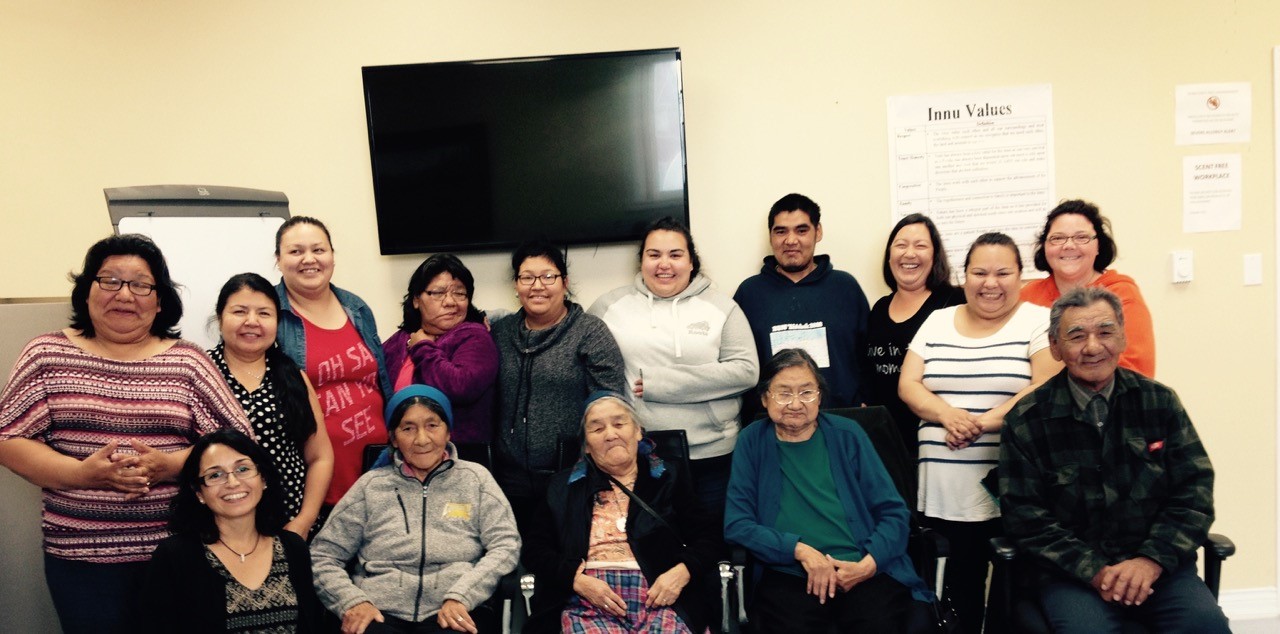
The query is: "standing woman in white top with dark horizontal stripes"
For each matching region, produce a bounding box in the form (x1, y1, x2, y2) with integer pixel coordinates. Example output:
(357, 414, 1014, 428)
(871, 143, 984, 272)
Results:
(899, 233, 1062, 634)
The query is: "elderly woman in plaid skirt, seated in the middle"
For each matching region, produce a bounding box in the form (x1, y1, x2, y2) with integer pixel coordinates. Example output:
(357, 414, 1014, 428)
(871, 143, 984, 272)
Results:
(524, 392, 717, 634)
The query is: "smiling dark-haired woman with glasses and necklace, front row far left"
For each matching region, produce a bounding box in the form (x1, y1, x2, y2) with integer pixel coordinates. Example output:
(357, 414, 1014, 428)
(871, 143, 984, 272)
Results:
(128, 429, 323, 633)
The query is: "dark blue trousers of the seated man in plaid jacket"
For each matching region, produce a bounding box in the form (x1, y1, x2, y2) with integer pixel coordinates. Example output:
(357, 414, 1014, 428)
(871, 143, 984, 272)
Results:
(1041, 564, 1231, 634)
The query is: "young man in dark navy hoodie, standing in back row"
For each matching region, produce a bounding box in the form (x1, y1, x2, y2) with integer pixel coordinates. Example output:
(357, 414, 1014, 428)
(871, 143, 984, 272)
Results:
(733, 193, 870, 417)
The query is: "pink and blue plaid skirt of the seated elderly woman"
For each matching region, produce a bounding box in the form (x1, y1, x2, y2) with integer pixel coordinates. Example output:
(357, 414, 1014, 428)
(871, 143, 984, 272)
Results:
(561, 569, 690, 634)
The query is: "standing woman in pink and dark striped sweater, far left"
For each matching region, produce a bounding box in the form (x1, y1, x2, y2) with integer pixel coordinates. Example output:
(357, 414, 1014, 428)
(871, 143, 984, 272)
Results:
(0, 234, 250, 633)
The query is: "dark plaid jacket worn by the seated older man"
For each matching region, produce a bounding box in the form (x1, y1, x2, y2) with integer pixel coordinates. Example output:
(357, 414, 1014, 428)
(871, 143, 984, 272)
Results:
(1000, 368, 1213, 583)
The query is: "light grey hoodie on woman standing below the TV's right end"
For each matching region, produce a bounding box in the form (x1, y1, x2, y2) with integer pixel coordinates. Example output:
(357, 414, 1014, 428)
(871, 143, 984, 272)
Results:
(588, 273, 760, 460)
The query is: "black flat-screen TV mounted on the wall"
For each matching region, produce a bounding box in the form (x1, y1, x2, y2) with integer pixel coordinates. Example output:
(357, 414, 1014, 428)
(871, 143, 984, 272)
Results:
(364, 49, 689, 255)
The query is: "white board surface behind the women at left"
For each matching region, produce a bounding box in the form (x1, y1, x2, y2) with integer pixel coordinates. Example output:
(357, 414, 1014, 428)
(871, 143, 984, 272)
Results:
(119, 214, 284, 348)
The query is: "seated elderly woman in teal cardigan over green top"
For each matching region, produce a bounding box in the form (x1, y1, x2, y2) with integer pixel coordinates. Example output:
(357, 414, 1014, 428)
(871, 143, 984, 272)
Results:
(724, 348, 931, 631)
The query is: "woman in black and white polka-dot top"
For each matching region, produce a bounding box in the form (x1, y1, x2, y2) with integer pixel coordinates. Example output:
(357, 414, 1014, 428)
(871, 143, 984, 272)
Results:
(209, 273, 333, 537)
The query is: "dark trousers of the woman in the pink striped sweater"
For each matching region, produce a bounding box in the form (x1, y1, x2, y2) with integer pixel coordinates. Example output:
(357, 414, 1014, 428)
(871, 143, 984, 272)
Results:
(45, 553, 147, 634)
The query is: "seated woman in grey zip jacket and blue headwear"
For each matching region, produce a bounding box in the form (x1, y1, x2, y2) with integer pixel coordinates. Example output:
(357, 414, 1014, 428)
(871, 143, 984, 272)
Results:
(311, 384, 520, 634)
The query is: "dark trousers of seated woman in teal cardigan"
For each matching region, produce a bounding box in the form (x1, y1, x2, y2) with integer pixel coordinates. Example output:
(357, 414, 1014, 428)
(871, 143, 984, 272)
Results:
(751, 569, 911, 634)
